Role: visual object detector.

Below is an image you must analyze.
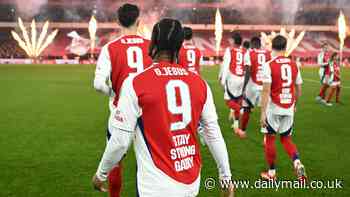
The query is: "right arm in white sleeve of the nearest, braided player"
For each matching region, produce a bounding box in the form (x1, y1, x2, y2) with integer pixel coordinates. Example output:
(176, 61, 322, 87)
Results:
(201, 82, 232, 195)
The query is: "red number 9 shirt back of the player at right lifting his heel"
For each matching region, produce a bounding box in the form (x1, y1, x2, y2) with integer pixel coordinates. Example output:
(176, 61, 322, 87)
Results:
(269, 56, 301, 108)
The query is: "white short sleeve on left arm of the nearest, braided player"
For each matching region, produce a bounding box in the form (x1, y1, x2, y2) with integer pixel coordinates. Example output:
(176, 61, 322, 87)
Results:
(112, 76, 141, 132)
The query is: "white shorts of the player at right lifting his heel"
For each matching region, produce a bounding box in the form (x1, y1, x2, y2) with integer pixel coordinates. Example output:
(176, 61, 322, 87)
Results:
(261, 113, 294, 135)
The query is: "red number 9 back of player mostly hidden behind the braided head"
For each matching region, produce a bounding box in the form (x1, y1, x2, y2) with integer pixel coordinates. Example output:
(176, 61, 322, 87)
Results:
(178, 44, 202, 74)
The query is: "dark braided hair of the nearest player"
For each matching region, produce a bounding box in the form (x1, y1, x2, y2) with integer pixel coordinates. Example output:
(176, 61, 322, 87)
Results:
(148, 18, 184, 60)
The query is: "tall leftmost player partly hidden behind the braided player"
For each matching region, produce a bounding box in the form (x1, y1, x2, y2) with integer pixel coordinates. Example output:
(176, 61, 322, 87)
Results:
(94, 4, 152, 197)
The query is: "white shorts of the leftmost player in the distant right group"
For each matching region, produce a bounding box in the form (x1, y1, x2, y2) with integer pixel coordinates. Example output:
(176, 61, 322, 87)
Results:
(224, 73, 244, 100)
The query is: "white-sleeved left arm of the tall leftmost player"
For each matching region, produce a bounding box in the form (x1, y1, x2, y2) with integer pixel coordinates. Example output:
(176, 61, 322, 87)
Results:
(94, 45, 113, 96)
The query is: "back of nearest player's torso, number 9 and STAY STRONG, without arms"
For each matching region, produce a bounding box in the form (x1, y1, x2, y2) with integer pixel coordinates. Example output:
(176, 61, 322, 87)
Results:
(132, 62, 207, 196)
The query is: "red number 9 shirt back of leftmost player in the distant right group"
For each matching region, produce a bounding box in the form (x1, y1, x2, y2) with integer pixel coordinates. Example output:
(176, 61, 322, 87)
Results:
(230, 47, 246, 77)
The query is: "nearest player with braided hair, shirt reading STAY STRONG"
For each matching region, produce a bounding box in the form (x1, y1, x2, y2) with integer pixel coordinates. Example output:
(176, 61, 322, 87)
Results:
(93, 19, 233, 197)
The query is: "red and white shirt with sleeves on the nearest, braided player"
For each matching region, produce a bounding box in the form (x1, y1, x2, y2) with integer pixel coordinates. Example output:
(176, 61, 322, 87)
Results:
(108, 62, 231, 196)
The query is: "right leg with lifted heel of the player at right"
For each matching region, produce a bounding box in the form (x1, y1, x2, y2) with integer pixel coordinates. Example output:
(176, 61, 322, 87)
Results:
(280, 116, 306, 180)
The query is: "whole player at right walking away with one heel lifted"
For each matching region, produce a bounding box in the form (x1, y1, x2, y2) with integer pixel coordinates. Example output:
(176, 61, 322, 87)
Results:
(260, 35, 306, 181)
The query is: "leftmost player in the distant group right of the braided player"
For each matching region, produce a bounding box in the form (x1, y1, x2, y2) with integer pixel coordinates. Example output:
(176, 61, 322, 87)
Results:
(221, 32, 246, 136)
